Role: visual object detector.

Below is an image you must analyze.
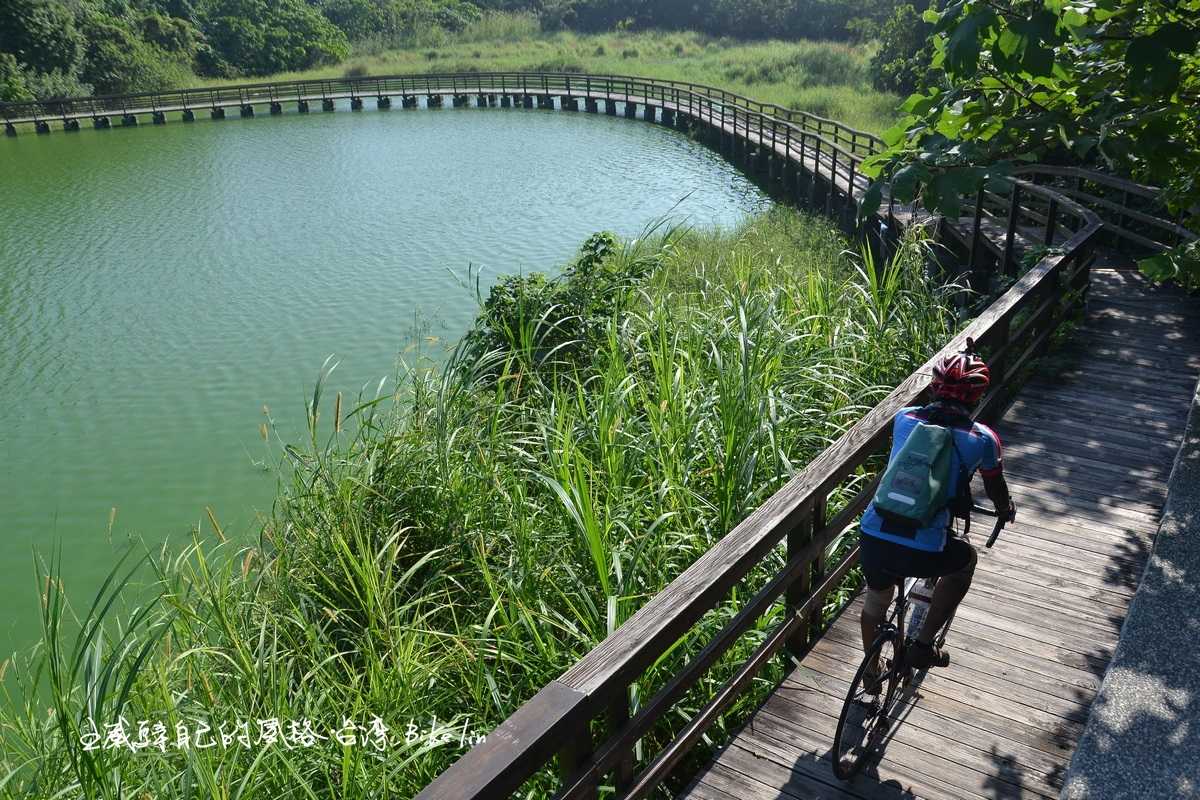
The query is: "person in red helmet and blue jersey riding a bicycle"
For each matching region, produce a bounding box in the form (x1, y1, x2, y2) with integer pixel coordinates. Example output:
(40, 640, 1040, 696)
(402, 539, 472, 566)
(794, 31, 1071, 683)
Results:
(860, 343, 1016, 676)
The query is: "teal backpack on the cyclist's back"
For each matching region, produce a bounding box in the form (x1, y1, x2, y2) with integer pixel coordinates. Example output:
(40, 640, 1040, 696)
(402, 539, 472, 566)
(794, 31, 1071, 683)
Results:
(875, 421, 955, 528)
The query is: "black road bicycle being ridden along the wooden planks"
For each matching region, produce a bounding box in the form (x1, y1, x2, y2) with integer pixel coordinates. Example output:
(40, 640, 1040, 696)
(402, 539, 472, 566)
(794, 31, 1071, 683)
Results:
(832, 503, 1008, 781)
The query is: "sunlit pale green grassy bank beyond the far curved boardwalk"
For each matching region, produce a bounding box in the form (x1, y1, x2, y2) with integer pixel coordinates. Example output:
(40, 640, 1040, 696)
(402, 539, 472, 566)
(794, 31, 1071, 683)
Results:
(204, 20, 900, 132)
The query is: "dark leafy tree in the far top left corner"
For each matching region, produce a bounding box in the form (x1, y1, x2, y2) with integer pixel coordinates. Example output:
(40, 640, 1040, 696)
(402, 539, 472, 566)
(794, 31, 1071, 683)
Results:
(0, 0, 84, 73)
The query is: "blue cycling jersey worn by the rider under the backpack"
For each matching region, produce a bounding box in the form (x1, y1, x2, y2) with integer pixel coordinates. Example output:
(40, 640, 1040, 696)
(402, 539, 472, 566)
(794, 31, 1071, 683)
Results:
(860, 405, 1001, 553)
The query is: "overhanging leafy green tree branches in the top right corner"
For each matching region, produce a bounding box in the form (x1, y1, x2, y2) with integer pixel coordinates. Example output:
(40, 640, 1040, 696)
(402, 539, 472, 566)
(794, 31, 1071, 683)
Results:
(865, 0, 1200, 288)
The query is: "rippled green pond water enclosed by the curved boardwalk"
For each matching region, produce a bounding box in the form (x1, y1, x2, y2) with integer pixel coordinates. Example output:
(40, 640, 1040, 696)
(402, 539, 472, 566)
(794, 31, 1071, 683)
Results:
(0, 107, 768, 656)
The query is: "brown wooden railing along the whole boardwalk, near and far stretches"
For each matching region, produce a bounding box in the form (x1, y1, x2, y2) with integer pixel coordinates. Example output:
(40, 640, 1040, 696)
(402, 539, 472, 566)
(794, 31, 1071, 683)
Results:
(0, 72, 1161, 800)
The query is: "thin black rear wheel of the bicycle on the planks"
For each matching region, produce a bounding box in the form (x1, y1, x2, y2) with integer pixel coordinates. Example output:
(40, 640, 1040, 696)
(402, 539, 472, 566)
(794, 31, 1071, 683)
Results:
(832, 628, 902, 781)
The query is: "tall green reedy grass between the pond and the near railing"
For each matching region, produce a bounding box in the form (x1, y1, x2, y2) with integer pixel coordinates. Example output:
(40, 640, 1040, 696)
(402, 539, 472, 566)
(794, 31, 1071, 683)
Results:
(0, 210, 953, 799)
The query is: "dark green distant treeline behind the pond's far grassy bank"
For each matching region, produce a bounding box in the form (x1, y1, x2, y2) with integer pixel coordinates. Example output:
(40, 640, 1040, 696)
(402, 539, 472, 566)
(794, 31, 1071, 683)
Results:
(0, 0, 898, 101)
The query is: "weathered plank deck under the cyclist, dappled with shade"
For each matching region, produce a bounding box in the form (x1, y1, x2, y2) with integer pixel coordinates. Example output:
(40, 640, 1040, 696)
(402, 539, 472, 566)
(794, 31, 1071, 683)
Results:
(679, 267, 1200, 800)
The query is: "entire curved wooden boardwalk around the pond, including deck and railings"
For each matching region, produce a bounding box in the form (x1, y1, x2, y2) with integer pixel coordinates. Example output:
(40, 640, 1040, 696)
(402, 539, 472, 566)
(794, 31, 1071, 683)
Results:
(11, 73, 1200, 800)
